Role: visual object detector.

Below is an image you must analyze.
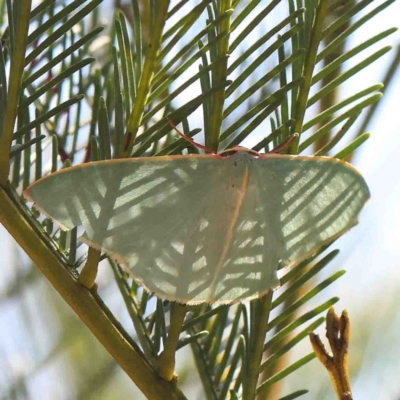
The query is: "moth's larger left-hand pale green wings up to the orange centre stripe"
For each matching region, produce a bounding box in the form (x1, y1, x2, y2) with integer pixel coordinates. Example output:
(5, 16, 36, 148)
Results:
(26, 156, 268, 303)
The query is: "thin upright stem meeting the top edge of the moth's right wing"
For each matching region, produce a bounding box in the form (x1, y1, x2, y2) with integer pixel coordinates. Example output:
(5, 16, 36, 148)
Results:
(289, 0, 329, 154)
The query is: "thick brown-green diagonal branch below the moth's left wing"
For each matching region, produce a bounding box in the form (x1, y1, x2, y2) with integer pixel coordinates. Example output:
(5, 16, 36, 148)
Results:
(0, 187, 186, 400)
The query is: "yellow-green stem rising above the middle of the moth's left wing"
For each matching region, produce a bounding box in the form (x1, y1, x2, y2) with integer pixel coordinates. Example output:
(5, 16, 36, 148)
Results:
(122, 0, 169, 157)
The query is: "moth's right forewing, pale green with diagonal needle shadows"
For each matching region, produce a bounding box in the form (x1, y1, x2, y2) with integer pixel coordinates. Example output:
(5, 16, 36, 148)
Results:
(255, 154, 370, 267)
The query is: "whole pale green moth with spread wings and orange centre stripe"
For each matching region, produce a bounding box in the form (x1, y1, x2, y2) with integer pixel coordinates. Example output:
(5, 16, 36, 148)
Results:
(25, 148, 369, 304)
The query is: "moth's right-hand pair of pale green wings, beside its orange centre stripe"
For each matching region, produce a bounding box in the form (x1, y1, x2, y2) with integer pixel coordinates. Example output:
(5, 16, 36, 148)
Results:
(198, 153, 369, 302)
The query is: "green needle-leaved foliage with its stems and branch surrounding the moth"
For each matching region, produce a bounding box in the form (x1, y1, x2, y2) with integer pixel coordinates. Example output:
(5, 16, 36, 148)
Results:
(0, 0, 398, 400)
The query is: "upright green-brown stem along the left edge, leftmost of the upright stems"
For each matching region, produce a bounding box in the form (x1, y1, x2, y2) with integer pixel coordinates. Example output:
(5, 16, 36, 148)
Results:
(0, 0, 31, 185)
